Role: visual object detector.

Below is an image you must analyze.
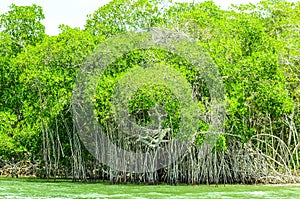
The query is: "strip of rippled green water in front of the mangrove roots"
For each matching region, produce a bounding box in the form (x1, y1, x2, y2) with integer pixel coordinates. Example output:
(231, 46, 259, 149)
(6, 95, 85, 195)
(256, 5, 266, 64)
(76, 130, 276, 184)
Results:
(0, 179, 300, 199)
